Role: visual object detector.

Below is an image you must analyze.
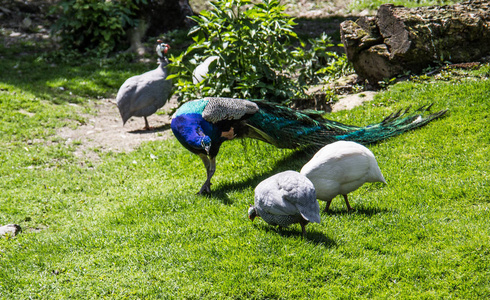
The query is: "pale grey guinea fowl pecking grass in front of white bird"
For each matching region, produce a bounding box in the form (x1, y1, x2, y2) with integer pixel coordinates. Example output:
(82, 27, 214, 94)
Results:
(248, 171, 320, 236)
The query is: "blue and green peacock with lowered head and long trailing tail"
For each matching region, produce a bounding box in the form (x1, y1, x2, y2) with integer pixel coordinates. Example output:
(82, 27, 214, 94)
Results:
(170, 97, 447, 194)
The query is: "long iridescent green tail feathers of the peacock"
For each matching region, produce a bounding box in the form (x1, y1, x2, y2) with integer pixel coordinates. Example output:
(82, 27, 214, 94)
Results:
(246, 100, 447, 148)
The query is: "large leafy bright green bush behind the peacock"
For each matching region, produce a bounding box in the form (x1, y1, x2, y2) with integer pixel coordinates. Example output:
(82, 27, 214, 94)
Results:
(170, 0, 347, 102)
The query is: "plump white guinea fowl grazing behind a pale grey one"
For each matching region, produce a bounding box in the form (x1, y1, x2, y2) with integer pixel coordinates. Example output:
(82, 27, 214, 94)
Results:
(300, 141, 386, 212)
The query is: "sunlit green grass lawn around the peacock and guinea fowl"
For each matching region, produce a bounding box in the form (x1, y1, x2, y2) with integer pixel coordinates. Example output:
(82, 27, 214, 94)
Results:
(0, 20, 490, 299)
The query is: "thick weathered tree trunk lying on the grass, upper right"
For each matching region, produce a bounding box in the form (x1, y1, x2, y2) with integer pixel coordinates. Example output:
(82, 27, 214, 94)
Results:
(340, 0, 490, 85)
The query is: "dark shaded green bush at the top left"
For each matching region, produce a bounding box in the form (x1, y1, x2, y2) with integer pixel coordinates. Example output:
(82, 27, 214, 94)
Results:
(52, 0, 147, 56)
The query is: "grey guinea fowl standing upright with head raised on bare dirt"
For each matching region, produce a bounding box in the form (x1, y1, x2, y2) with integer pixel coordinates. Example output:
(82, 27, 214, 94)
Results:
(116, 40, 172, 130)
